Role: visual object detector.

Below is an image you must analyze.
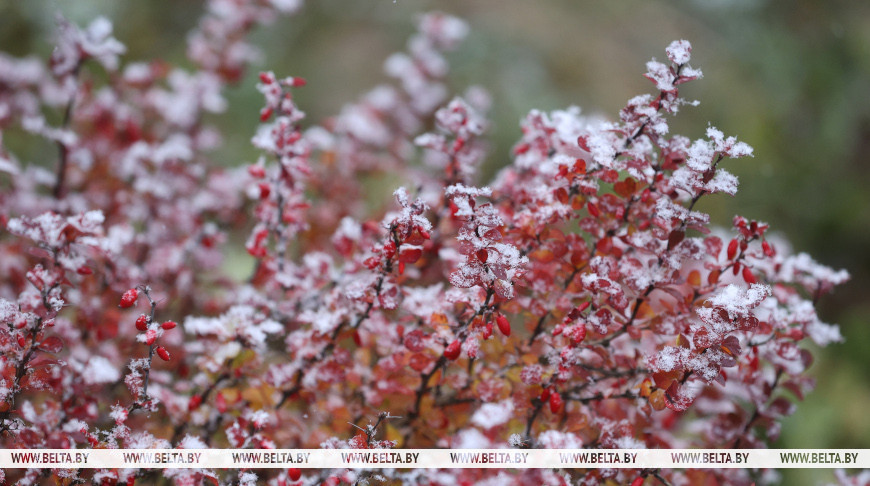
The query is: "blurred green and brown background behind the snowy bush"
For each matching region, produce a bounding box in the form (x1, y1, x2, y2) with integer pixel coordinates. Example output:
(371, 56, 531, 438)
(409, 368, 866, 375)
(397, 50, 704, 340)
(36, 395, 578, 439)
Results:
(0, 0, 870, 484)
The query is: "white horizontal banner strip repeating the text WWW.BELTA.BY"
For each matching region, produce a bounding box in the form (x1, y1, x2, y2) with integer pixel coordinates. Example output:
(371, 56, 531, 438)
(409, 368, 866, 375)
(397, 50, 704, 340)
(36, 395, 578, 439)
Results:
(0, 449, 870, 469)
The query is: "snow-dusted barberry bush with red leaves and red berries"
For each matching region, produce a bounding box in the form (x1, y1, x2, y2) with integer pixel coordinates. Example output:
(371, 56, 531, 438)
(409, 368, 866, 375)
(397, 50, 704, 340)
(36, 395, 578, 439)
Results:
(0, 0, 848, 485)
